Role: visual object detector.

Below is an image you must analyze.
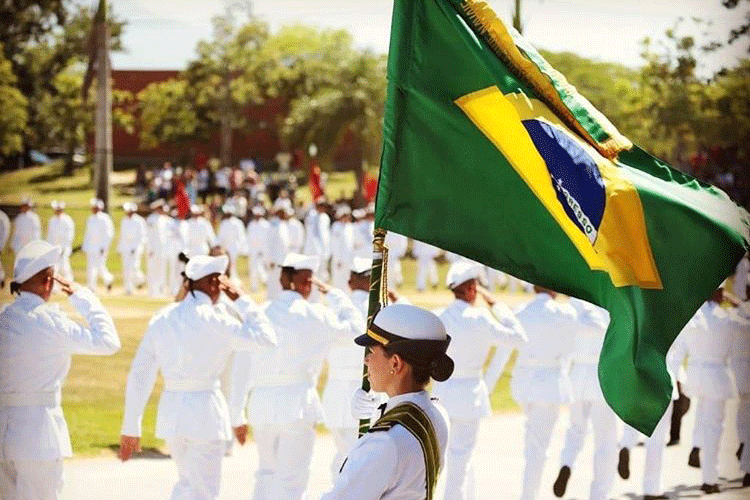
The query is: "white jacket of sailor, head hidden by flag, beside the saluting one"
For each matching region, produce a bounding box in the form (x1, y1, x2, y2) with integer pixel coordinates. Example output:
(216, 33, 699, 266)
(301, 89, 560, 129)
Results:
(510, 293, 578, 404)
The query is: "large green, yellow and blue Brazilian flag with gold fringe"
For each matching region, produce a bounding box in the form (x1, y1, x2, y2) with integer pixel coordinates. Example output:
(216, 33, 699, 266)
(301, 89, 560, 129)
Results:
(375, 0, 750, 435)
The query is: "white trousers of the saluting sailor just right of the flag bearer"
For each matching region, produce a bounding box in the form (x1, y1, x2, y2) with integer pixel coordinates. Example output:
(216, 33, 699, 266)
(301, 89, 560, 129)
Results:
(445, 419, 479, 500)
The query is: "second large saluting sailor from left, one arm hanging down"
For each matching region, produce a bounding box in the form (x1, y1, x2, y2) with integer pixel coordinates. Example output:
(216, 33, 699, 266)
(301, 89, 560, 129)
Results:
(120, 255, 276, 500)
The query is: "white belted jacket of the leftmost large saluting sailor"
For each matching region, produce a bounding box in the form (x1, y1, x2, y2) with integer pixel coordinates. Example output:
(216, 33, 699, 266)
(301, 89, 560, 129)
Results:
(0, 287, 120, 460)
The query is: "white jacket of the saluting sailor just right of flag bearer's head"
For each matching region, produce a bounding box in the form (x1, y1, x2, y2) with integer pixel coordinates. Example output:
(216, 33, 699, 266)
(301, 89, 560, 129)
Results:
(432, 299, 526, 420)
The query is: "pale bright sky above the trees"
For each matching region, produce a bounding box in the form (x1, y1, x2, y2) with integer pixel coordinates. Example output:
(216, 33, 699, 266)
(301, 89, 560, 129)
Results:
(85, 0, 747, 74)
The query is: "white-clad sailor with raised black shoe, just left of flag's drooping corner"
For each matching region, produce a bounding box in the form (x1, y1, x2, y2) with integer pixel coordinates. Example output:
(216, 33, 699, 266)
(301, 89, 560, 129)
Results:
(553, 297, 618, 500)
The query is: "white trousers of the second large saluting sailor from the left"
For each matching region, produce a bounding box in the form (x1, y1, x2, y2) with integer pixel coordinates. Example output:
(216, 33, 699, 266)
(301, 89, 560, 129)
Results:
(167, 438, 226, 500)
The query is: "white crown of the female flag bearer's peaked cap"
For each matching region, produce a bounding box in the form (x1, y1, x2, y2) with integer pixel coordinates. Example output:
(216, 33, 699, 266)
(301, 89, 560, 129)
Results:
(372, 304, 447, 340)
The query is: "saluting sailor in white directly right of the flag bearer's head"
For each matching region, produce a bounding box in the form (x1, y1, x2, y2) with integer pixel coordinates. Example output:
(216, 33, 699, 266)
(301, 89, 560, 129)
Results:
(432, 261, 526, 500)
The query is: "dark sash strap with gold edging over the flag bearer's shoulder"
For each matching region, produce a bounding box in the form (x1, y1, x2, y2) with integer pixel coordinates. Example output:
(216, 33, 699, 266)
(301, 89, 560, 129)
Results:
(367, 402, 440, 500)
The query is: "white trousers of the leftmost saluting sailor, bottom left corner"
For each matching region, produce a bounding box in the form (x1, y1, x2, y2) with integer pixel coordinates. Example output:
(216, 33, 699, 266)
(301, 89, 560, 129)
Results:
(0, 459, 63, 500)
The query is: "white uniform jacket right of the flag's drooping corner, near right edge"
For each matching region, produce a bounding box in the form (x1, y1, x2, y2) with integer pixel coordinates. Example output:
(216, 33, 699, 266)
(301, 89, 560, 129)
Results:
(684, 302, 747, 399)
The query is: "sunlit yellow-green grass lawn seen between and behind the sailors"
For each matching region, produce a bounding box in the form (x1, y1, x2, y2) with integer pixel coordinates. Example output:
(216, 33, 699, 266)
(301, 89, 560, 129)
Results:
(0, 164, 529, 456)
